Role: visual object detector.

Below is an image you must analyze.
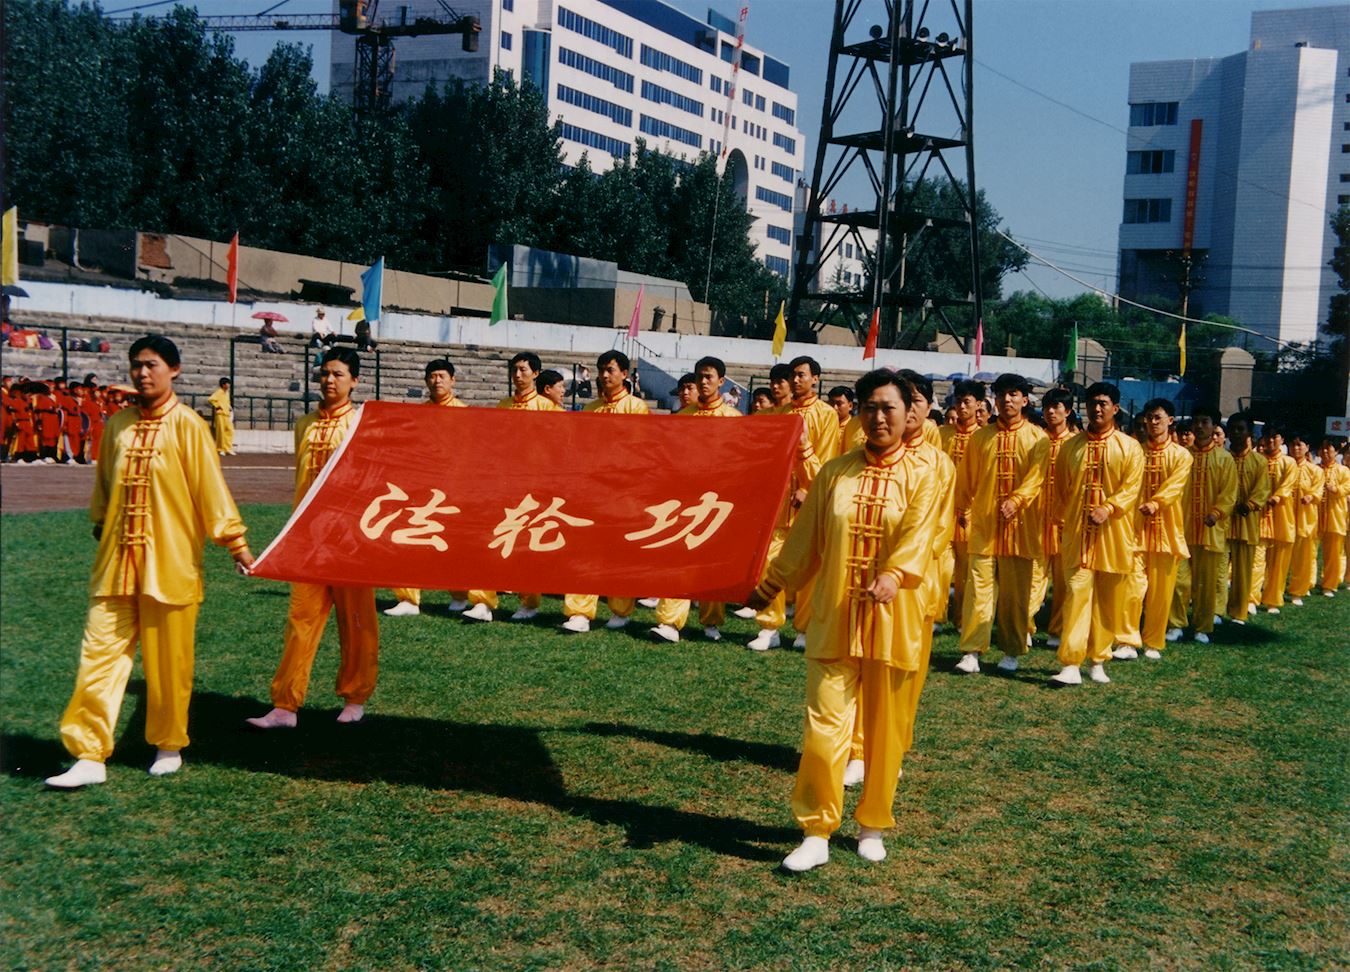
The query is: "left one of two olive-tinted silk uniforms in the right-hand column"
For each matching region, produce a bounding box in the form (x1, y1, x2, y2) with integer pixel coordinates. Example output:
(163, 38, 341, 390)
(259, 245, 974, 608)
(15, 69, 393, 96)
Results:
(1177, 439, 1238, 633)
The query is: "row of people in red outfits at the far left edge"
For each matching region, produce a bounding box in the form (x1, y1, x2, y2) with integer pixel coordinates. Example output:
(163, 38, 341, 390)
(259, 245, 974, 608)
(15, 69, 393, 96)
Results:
(0, 375, 128, 466)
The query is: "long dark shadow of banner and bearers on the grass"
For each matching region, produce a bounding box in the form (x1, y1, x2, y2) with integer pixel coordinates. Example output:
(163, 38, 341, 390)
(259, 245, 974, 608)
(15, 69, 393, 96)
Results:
(0, 682, 799, 861)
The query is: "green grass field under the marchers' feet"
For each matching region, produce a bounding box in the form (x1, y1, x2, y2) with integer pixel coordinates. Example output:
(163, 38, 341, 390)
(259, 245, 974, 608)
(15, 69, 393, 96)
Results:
(0, 506, 1350, 969)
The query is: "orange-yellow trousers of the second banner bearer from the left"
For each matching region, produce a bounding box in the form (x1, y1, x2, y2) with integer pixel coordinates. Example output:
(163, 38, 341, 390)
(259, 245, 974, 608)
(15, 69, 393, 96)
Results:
(271, 583, 379, 711)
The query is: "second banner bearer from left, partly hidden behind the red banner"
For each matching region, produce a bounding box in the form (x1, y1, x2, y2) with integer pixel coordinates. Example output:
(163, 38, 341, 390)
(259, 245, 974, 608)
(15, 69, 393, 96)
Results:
(246, 347, 379, 729)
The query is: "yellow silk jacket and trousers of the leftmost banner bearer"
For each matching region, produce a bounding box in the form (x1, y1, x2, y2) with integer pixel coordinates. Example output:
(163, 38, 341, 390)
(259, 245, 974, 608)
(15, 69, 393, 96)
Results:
(61, 396, 247, 763)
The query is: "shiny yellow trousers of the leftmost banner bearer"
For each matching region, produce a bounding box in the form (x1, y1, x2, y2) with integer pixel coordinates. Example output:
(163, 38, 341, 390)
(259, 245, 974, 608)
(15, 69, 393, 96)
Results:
(61, 597, 200, 763)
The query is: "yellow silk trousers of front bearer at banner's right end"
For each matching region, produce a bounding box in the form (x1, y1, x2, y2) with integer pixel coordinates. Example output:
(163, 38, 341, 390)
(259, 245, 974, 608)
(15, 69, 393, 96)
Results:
(792, 657, 915, 837)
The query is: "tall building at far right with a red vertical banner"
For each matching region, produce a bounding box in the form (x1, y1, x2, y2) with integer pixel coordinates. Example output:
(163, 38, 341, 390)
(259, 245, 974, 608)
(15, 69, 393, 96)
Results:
(1119, 5, 1350, 350)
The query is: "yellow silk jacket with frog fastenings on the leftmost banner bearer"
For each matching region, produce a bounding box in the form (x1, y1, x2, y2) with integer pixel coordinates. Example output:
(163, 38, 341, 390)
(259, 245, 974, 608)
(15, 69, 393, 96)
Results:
(89, 396, 246, 605)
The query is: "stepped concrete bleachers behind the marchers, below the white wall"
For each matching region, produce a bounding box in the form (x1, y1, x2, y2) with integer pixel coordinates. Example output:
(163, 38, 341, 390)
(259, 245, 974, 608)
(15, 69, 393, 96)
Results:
(0, 312, 948, 429)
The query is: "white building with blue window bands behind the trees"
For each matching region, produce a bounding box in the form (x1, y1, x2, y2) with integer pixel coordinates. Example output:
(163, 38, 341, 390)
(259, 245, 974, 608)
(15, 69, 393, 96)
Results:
(332, 0, 806, 277)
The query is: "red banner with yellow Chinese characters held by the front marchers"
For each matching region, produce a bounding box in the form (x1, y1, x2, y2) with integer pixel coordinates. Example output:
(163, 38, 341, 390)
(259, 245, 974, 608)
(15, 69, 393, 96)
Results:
(252, 402, 802, 601)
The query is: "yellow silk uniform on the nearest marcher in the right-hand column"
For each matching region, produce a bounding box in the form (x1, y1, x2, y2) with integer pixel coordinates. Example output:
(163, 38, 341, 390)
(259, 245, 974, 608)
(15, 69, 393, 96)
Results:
(1054, 428, 1143, 666)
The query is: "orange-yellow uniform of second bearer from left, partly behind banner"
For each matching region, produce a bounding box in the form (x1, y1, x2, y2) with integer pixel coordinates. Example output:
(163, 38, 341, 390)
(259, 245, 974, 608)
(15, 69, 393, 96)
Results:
(271, 401, 379, 711)
